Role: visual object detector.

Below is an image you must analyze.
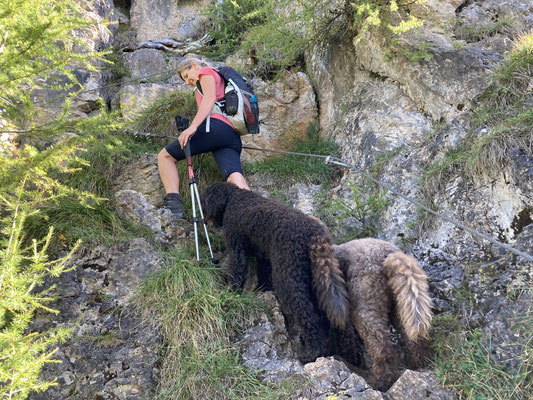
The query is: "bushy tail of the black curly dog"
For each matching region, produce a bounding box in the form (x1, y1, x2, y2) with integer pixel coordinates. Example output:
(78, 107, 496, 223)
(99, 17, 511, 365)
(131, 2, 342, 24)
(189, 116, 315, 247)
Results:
(309, 236, 350, 328)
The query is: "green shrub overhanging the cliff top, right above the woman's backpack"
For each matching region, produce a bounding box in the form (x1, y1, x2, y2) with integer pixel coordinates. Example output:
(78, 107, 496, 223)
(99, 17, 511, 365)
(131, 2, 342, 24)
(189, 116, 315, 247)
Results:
(200, 0, 422, 79)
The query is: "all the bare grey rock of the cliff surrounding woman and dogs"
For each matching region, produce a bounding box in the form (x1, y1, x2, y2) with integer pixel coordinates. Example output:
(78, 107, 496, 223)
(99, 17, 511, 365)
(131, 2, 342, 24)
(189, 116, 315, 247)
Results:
(34, 0, 533, 400)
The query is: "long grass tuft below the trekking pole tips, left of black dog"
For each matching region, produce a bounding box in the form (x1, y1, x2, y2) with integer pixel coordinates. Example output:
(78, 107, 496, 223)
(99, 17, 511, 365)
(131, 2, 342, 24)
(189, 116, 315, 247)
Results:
(137, 246, 298, 400)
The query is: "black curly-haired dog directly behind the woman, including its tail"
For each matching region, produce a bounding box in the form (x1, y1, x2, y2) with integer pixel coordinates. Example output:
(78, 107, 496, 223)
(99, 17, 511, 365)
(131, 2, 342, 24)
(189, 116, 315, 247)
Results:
(204, 182, 349, 362)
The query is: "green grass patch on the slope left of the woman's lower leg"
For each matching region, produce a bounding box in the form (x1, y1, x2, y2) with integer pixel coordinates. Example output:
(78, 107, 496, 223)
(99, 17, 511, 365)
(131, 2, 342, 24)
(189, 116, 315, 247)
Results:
(20, 134, 160, 249)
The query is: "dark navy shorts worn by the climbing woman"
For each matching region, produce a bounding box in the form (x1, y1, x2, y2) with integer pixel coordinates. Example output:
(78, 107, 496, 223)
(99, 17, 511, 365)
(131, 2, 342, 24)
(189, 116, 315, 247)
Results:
(165, 118, 243, 180)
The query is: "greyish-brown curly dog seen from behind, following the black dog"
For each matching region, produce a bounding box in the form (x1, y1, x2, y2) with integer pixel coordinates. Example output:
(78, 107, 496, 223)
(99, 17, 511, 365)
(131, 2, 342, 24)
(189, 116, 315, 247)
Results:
(334, 238, 432, 391)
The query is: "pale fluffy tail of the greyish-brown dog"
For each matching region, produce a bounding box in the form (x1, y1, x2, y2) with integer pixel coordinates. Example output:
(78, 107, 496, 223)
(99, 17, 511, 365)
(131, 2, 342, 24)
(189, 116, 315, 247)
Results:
(383, 251, 432, 341)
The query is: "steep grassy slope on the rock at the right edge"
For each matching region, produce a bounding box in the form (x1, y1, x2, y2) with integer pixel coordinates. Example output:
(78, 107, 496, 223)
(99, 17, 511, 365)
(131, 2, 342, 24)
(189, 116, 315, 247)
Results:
(422, 33, 533, 199)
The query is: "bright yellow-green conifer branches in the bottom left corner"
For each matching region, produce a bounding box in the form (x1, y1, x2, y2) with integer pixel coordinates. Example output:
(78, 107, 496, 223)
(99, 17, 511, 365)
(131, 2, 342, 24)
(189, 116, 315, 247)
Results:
(0, 208, 76, 400)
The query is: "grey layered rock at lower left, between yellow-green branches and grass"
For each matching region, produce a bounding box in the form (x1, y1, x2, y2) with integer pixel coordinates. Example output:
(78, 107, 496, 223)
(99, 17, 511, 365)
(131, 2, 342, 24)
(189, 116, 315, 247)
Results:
(29, 239, 163, 400)
